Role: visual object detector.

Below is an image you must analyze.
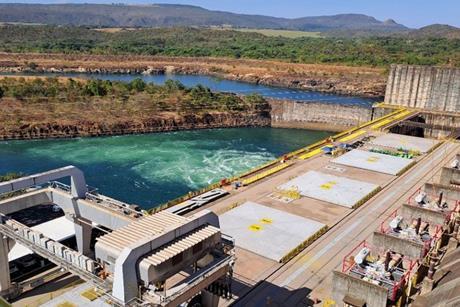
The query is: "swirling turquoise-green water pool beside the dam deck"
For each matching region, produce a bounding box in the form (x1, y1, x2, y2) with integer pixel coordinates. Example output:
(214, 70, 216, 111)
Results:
(0, 128, 329, 208)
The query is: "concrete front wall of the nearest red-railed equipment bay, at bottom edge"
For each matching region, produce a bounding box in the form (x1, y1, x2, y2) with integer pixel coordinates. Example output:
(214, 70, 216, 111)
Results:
(332, 271, 388, 307)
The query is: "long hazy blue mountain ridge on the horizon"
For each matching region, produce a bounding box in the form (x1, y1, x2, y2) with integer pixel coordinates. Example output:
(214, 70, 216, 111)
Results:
(0, 3, 408, 33)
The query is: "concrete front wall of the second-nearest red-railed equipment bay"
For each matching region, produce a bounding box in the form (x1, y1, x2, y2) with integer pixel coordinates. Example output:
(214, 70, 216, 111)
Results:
(373, 232, 424, 259)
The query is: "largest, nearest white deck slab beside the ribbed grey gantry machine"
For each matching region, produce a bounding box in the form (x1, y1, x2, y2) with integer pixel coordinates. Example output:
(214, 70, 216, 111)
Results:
(220, 202, 325, 261)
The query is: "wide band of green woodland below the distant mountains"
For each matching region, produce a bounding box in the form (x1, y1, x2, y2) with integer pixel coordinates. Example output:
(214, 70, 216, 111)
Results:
(0, 26, 460, 66)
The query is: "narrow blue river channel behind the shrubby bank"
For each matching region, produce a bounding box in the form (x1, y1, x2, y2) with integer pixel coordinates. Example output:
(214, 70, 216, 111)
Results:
(2, 73, 377, 107)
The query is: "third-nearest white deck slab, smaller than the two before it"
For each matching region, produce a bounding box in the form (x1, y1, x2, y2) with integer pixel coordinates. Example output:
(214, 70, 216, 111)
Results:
(332, 149, 413, 175)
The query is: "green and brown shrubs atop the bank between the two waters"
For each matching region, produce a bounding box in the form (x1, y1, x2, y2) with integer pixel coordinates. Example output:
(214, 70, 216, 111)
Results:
(0, 78, 267, 113)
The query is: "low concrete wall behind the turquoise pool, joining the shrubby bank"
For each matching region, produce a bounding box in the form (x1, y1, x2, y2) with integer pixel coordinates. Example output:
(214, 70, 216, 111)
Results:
(269, 100, 373, 131)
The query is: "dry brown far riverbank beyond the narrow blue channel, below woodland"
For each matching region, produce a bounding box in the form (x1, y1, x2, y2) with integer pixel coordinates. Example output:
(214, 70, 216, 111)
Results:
(0, 53, 386, 98)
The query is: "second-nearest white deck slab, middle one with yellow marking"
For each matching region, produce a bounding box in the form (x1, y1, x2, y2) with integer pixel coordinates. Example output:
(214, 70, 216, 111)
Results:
(279, 171, 378, 208)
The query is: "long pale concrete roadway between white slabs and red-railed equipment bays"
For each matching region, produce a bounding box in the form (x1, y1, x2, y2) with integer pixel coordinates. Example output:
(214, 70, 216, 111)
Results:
(235, 143, 460, 306)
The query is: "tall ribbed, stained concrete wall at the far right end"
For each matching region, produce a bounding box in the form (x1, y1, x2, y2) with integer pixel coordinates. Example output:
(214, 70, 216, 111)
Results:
(385, 65, 460, 112)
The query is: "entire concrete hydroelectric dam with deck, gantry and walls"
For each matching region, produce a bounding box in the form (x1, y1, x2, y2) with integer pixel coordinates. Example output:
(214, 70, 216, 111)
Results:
(0, 66, 460, 306)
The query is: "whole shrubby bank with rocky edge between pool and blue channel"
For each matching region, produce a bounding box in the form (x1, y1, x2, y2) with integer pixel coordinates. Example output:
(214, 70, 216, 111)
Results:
(0, 78, 271, 140)
